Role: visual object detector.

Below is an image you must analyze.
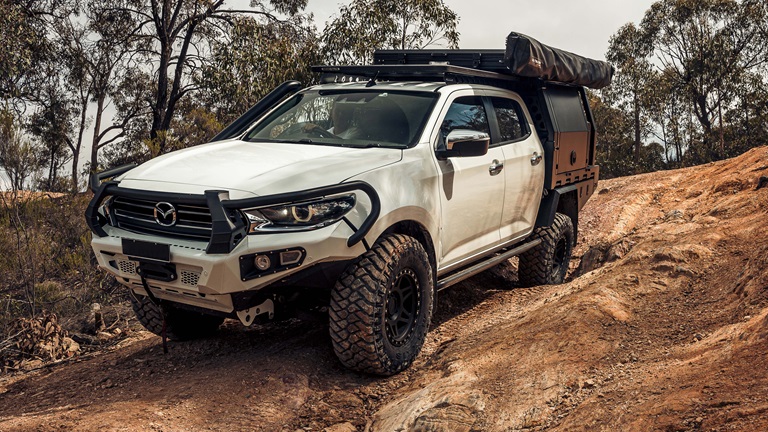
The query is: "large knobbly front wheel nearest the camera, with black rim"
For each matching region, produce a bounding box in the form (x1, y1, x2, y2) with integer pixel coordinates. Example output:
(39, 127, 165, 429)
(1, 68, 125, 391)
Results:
(329, 234, 434, 376)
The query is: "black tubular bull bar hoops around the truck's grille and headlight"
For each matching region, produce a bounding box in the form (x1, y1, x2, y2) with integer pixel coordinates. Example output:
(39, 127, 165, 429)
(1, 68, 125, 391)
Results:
(85, 174, 381, 254)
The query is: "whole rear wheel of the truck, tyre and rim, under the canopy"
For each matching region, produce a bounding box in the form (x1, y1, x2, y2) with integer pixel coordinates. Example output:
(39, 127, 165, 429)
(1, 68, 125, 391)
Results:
(518, 213, 575, 287)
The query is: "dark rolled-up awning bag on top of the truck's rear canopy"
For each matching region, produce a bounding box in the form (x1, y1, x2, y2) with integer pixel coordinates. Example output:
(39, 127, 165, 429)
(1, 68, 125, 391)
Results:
(504, 32, 613, 89)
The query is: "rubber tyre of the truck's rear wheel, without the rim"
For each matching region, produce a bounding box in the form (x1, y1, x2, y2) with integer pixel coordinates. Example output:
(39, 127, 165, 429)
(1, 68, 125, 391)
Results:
(518, 213, 575, 287)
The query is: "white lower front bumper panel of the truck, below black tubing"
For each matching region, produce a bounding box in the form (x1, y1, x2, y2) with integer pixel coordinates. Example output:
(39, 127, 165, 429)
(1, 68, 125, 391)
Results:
(91, 222, 365, 313)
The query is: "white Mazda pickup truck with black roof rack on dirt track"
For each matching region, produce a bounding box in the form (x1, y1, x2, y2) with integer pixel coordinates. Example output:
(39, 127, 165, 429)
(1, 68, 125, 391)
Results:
(86, 44, 612, 375)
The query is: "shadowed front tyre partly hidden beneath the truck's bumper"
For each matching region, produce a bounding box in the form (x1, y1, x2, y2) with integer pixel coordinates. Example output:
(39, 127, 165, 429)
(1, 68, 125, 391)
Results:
(128, 293, 224, 341)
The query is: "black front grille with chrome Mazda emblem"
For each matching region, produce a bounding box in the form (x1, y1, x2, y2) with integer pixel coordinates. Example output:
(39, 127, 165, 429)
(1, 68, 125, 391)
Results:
(110, 197, 211, 241)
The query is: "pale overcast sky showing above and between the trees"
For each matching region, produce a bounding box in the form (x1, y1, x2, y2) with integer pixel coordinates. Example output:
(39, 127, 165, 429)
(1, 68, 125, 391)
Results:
(0, 0, 654, 189)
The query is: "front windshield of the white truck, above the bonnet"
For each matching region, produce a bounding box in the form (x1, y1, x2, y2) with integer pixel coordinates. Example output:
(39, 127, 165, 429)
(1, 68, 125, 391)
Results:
(245, 90, 437, 148)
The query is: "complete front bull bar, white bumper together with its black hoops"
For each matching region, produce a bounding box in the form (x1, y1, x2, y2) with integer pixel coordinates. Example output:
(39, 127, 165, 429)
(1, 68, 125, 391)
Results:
(85, 166, 380, 313)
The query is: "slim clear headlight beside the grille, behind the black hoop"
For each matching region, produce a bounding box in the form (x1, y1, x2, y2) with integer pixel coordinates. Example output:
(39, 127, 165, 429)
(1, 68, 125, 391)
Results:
(243, 194, 355, 234)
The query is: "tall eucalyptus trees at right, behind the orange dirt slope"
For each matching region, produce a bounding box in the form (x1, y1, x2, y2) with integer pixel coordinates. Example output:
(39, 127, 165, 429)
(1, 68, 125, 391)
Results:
(598, 0, 768, 174)
